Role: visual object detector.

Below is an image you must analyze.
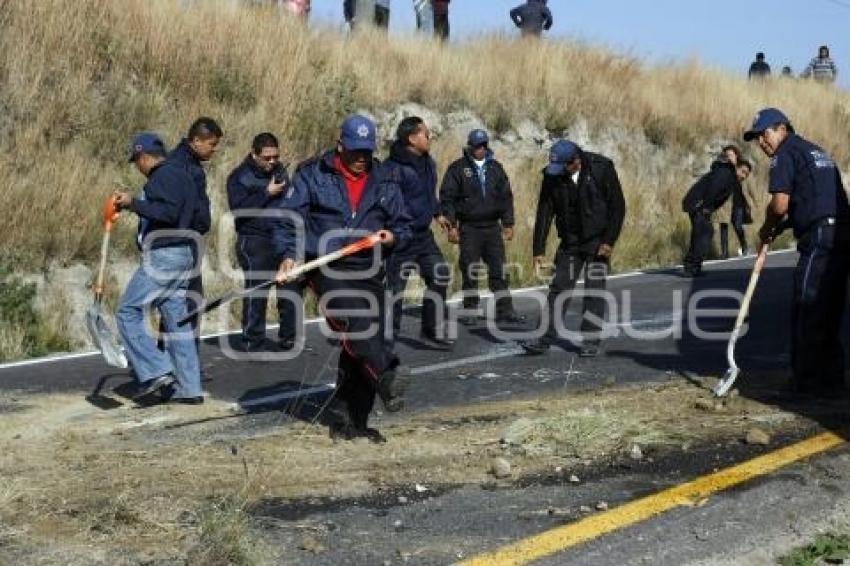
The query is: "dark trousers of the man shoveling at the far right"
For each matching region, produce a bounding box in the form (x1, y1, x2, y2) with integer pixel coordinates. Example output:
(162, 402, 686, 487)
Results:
(791, 224, 850, 391)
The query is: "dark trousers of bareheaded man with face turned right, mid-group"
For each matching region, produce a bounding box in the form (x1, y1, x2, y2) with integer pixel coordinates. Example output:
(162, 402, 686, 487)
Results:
(387, 229, 450, 342)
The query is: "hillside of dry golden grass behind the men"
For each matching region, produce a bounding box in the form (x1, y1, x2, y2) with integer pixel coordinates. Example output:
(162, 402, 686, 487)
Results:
(0, 0, 850, 362)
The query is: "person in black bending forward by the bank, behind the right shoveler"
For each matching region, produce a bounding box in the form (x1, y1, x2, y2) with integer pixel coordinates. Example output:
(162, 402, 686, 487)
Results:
(682, 159, 752, 277)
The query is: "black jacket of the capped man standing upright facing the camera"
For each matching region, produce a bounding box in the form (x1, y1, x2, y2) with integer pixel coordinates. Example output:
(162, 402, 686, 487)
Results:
(440, 151, 514, 228)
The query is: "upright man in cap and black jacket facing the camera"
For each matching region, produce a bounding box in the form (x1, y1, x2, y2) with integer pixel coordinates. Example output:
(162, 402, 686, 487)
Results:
(440, 130, 524, 324)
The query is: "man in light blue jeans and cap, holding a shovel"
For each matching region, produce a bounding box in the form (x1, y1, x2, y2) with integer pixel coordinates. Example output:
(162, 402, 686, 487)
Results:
(114, 133, 204, 404)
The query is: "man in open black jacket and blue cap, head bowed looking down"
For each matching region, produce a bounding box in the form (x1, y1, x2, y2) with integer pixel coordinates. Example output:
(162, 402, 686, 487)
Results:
(521, 140, 626, 357)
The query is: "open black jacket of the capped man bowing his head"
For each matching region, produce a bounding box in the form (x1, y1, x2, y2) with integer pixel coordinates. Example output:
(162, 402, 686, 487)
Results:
(532, 151, 626, 256)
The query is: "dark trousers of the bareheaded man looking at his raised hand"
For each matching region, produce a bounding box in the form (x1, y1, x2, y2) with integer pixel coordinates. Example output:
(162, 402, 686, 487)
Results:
(236, 236, 306, 345)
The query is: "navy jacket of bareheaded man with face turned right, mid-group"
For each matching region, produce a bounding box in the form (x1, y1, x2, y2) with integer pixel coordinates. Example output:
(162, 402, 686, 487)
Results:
(383, 142, 440, 232)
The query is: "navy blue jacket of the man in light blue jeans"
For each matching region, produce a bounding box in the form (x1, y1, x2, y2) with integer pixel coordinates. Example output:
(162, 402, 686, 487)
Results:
(130, 161, 198, 248)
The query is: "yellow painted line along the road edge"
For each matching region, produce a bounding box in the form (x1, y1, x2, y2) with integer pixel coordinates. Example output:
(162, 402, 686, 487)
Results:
(459, 432, 844, 566)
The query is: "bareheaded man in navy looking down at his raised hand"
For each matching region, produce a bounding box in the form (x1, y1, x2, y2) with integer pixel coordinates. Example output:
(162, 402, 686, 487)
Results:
(227, 132, 303, 352)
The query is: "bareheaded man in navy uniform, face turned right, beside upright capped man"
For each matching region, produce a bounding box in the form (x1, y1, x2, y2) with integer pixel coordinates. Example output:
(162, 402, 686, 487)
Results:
(384, 116, 453, 350)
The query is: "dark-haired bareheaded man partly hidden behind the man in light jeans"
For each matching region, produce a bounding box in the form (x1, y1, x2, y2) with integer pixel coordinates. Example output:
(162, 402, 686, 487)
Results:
(168, 116, 224, 366)
